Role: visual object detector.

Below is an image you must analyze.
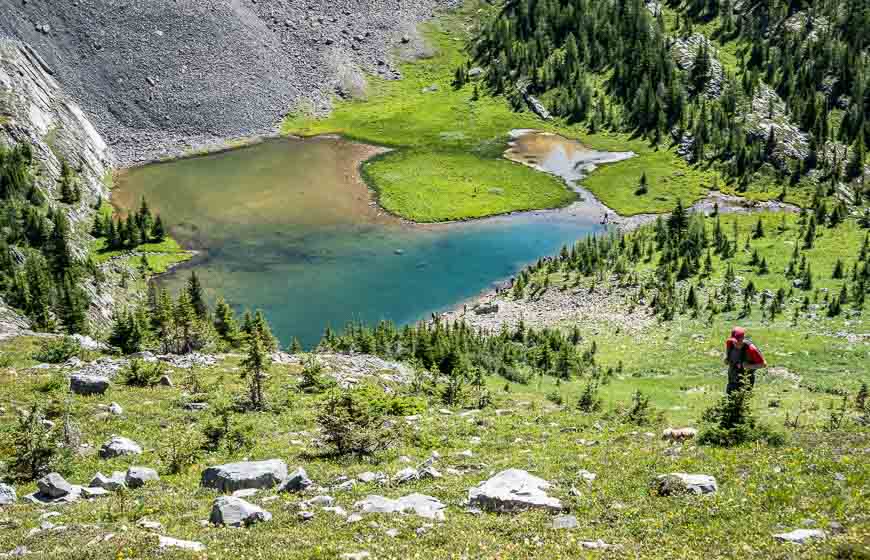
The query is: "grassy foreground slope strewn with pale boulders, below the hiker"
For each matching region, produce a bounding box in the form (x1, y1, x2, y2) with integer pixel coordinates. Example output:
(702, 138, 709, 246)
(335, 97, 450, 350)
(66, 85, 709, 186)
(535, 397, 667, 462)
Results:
(0, 326, 870, 560)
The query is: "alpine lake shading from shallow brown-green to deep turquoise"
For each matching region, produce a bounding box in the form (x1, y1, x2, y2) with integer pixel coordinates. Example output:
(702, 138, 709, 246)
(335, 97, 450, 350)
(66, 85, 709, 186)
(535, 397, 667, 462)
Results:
(113, 137, 601, 345)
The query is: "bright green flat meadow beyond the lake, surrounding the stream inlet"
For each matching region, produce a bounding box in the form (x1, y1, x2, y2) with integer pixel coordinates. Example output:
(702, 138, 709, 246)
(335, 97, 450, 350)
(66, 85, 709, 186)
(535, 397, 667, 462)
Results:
(281, 2, 715, 222)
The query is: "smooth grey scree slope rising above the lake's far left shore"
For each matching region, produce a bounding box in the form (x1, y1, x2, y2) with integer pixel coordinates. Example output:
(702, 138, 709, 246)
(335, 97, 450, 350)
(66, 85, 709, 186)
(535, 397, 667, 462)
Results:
(0, 0, 448, 163)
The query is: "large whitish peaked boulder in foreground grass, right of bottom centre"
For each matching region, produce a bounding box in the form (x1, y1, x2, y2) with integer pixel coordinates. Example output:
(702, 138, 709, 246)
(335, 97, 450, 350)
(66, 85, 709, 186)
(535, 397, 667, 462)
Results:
(468, 469, 562, 513)
